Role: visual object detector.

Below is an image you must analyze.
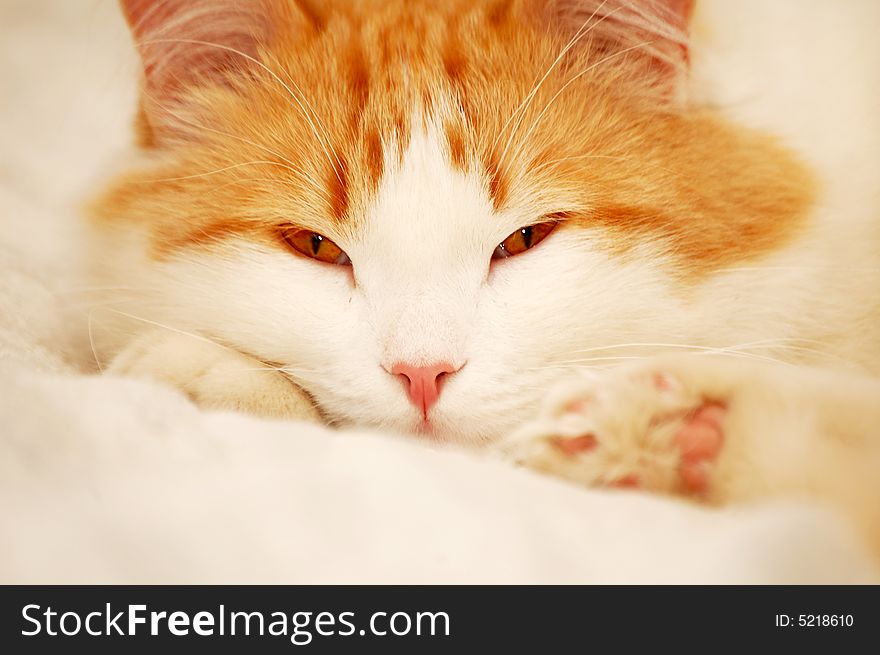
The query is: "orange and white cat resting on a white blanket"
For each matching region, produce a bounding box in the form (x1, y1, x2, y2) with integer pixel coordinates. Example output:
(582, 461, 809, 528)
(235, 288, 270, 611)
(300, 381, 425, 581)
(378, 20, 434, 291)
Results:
(91, 0, 880, 548)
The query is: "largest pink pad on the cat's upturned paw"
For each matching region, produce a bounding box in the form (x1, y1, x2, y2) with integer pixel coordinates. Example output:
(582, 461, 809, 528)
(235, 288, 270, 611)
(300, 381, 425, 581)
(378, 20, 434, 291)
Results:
(675, 402, 727, 492)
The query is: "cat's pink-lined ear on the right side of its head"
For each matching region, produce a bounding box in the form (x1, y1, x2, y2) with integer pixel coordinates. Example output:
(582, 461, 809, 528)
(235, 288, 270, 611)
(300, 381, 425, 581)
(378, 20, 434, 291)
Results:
(535, 0, 695, 94)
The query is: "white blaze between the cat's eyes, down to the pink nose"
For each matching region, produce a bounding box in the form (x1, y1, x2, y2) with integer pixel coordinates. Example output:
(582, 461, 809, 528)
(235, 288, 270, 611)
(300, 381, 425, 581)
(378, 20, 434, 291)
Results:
(349, 121, 506, 366)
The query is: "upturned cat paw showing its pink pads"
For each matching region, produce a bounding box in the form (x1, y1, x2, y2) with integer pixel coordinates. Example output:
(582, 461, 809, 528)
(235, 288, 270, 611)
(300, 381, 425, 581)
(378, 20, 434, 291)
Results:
(501, 364, 729, 500)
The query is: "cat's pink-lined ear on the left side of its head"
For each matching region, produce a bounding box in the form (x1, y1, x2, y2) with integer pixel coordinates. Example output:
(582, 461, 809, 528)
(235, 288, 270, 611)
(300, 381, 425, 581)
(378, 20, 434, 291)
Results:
(120, 0, 271, 143)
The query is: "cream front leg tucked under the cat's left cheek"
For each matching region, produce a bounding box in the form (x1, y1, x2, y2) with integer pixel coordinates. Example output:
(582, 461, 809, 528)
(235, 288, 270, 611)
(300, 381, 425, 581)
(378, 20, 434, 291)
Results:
(106, 329, 321, 421)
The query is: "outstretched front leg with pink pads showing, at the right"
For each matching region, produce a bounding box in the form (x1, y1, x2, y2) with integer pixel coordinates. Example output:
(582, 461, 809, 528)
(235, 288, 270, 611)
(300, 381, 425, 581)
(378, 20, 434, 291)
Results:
(500, 355, 880, 521)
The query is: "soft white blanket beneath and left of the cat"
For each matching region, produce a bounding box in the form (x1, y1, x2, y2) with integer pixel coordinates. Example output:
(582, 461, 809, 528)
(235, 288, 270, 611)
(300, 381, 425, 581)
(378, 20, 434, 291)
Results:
(0, 0, 878, 583)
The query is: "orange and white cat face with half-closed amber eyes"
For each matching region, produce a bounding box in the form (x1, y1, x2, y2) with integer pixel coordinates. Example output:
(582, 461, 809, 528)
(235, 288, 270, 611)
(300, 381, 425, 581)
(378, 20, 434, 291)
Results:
(96, 0, 810, 442)
